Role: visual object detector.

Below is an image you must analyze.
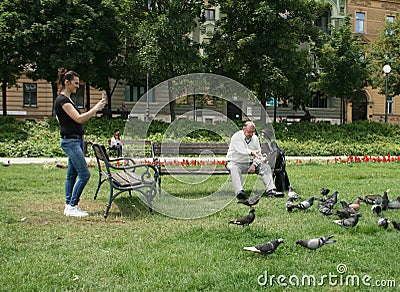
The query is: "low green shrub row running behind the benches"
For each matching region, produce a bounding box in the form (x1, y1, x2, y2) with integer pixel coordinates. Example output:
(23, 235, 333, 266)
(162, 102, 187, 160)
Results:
(0, 117, 400, 157)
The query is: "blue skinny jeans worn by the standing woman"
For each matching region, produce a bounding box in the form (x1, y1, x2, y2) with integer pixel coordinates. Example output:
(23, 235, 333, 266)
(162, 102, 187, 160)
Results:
(61, 138, 90, 206)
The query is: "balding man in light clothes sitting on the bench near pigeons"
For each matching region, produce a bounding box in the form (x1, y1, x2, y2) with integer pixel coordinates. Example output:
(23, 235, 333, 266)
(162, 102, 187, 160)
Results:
(226, 121, 284, 200)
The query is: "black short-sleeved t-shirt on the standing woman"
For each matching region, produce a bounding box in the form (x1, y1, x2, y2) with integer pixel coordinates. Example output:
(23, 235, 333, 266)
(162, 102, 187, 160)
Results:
(54, 94, 84, 136)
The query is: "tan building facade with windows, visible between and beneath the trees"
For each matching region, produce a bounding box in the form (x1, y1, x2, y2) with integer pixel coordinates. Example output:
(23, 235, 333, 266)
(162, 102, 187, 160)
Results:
(0, 0, 400, 123)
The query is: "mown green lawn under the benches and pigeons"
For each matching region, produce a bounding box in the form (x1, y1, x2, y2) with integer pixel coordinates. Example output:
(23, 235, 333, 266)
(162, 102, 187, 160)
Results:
(0, 163, 400, 291)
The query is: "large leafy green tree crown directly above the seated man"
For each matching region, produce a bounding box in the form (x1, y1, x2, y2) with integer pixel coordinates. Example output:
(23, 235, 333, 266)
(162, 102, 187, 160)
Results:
(206, 0, 326, 112)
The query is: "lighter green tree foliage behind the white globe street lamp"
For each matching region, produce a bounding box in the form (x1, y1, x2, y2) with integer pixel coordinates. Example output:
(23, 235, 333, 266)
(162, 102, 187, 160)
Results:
(368, 16, 400, 96)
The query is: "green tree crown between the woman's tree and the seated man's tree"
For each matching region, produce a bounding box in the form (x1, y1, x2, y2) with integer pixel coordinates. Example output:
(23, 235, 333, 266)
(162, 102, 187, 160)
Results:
(119, 0, 204, 120)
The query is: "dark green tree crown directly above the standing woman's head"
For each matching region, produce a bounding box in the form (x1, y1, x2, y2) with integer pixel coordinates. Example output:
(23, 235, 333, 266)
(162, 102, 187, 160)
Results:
(25, 0, 120, 99)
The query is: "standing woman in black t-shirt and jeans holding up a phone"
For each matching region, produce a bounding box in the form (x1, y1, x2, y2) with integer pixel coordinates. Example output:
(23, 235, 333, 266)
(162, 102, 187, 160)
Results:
(55, 68, 105, 217)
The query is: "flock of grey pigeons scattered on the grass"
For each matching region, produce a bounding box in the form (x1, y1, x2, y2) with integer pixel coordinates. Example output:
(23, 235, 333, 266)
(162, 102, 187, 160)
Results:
(229, 186, 400, 257)
